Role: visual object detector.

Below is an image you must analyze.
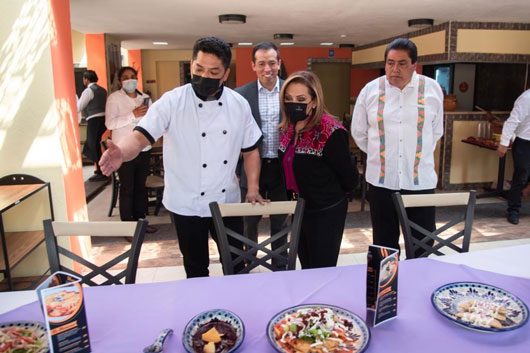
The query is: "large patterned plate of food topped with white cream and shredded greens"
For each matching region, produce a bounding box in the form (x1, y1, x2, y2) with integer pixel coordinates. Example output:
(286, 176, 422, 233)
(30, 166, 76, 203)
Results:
(267, 304, 370, 353)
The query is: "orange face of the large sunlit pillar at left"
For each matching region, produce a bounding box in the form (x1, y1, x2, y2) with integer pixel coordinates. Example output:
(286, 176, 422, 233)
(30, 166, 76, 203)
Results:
(49, 0, 86, 264)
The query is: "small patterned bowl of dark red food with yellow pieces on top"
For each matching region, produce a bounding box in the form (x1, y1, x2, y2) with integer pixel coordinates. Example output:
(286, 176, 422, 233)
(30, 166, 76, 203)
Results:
(182, 309, 245, 353)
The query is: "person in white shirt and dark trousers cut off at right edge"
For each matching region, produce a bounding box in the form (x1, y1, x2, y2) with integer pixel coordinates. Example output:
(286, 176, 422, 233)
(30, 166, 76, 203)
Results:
(497, 89, 530, 224)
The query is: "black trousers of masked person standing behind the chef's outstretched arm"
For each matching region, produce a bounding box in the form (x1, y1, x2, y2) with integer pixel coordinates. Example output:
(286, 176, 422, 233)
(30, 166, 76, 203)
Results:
(118, 151, 151, 221)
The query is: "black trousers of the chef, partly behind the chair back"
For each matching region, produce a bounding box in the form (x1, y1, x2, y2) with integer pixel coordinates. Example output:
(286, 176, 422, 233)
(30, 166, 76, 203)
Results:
(170, 212, 244, 278)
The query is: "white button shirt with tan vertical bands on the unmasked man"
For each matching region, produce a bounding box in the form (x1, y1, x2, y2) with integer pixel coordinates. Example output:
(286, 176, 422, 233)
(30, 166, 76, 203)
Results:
(351, 72, 443, 190)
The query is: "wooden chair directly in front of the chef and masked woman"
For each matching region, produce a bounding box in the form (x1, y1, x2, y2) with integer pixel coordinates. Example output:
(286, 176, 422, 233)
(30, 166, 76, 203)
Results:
(210, 199, 305, 275)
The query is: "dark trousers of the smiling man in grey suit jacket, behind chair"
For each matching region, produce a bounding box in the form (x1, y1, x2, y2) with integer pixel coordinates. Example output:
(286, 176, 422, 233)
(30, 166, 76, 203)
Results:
(241, 158, 287, 264)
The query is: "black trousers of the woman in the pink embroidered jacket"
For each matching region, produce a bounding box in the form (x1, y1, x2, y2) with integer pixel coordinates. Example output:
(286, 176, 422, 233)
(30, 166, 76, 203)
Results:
(298, 197, 348, 269)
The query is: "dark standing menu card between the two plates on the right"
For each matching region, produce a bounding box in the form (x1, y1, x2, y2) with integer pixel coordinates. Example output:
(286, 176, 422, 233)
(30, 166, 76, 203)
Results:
(366, 245, 399, 327)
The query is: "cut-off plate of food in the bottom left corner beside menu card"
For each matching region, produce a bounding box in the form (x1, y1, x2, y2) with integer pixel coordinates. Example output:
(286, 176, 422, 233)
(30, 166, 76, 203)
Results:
(0, 321, 49, 353)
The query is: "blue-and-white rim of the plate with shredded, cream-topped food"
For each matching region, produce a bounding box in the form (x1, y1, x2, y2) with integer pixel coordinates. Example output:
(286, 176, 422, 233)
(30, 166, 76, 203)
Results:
(267, 304, 370, 353)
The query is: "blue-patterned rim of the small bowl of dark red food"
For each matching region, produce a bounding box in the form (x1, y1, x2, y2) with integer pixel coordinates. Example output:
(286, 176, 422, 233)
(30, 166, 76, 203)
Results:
(182, 309, 245, 353)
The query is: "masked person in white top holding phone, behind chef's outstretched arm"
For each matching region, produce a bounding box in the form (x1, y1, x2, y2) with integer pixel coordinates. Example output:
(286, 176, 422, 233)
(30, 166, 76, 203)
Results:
(105, 66, 157, 233)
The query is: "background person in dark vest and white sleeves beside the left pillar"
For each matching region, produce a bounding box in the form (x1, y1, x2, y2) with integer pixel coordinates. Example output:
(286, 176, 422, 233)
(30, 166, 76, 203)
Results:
(77, 70, 107, 181)
